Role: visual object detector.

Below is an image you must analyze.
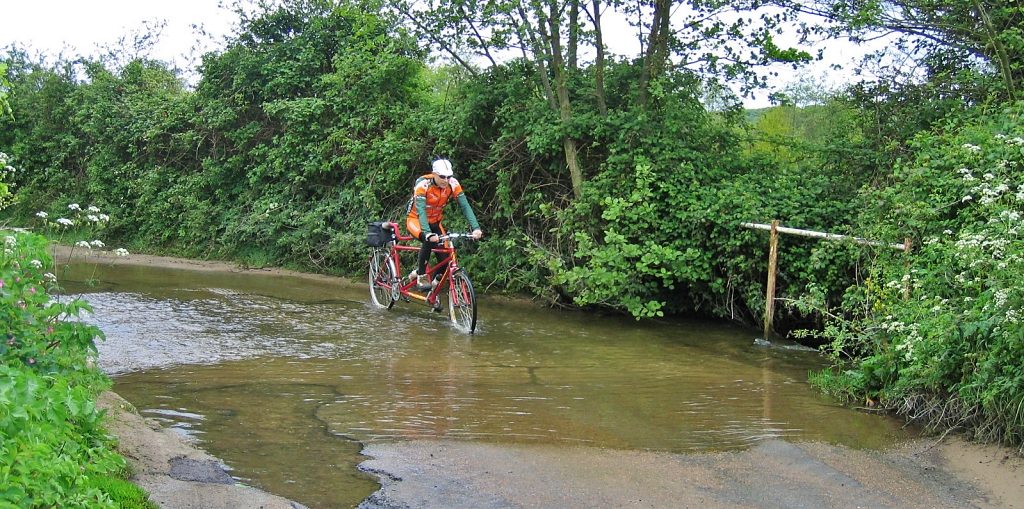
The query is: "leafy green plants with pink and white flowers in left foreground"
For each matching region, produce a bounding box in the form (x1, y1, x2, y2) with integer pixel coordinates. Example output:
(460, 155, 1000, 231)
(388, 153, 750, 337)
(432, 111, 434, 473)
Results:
(0, 231, 144, 508)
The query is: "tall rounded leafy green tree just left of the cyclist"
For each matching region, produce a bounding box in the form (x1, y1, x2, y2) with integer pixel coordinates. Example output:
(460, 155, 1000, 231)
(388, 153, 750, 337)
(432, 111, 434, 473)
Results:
(184, 0, 428, 267)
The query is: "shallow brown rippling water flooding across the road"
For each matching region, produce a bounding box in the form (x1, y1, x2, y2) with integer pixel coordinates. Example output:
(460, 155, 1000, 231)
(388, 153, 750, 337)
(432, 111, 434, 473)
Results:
(61, 266, 902, 508)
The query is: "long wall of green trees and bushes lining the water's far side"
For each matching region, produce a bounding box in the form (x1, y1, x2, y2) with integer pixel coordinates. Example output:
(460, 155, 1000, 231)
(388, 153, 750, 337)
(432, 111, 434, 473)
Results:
(0, 0, 1024, 450)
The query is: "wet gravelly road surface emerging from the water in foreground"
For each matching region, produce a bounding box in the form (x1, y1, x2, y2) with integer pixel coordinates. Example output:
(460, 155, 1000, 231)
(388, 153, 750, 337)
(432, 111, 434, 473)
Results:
(359, 440, 991, 509)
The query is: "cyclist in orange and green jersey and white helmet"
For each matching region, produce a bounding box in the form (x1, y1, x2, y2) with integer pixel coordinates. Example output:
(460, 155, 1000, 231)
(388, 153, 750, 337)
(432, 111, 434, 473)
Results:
(406, 159, 483, 291)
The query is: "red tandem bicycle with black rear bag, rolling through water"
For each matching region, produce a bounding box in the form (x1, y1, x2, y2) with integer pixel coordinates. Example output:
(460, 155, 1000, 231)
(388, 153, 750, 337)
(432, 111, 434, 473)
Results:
(367, 221, 476, 334)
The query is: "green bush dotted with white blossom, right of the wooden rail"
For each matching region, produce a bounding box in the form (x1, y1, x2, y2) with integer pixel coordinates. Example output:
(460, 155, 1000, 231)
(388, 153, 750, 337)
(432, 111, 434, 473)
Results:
(815, 104, 1024, 444)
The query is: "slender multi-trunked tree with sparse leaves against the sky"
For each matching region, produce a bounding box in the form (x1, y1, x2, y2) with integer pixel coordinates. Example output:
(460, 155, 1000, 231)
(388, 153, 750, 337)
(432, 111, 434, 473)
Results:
(392, 0, 811, 199)
